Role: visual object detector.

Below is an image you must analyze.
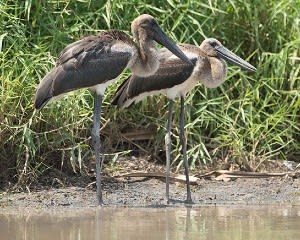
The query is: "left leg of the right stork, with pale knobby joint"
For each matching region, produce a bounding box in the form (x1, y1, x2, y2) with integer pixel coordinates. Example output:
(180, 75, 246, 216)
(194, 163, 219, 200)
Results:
(165, 100, 174, 203)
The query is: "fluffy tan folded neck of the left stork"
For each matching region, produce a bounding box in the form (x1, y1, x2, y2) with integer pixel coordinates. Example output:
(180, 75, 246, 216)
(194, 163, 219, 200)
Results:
(131, 40, 159, 77)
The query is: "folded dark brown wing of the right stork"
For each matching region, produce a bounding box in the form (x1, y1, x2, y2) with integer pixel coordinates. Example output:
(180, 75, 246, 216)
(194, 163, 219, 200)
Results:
(112, 55, 196, 107)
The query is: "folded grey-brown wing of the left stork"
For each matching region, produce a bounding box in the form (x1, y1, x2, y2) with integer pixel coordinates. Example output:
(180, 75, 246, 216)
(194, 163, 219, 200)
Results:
(34, 30, 134, 108)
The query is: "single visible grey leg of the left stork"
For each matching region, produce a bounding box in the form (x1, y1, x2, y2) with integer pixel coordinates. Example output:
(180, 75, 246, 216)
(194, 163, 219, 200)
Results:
(92, 92, 103, 205)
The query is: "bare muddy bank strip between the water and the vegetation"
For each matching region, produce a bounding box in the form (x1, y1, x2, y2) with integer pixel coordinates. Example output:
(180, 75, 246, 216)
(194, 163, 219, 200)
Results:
(0, 174, 300, 210)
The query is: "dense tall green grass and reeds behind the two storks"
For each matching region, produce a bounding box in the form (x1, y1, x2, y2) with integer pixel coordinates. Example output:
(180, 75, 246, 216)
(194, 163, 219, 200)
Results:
(0, 0, 300, 186)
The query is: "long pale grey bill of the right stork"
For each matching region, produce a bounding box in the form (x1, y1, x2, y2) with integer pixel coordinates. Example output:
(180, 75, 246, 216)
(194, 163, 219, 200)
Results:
(215, 46, 256, 72)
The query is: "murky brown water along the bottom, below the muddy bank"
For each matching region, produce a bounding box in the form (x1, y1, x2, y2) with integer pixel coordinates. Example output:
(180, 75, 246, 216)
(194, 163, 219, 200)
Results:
(0, 206, 300, 240)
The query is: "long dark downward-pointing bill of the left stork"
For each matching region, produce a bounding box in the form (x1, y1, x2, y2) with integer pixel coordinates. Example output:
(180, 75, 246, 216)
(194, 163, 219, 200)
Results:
(153, 26, 194, 65)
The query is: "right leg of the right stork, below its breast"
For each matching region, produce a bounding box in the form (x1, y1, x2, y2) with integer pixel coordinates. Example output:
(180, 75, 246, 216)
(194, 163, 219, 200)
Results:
(180, 96, 193, 203)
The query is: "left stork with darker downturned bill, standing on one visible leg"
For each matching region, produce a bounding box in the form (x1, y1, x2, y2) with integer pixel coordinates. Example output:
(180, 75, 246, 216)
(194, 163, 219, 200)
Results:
(33, 14, 192, 205)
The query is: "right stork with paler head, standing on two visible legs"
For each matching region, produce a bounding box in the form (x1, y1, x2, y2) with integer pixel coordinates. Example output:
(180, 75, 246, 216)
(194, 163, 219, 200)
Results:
(111, 38, 256, 203)
